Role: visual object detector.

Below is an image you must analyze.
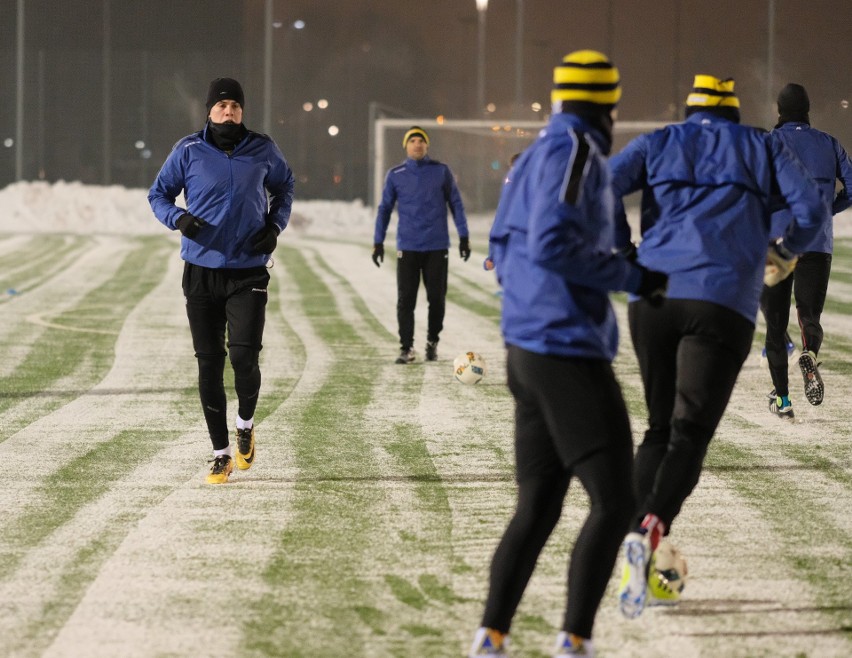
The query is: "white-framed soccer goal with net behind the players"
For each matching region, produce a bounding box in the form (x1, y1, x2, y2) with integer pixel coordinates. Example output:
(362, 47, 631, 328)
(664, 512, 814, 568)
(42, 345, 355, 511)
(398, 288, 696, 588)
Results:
(370, 117, 666, 213)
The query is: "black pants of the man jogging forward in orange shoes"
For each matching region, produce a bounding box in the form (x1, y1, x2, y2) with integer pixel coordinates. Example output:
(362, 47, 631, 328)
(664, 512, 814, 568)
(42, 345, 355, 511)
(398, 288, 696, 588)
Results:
(183, 263, 269, 450)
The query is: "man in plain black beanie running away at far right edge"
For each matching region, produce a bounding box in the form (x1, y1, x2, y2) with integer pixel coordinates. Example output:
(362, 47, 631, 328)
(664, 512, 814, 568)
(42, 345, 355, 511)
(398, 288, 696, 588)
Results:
(761, 83, 852, 418)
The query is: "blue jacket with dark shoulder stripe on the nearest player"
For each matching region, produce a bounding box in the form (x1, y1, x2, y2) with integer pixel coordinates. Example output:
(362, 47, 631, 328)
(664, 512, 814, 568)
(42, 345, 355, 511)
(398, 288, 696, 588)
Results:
(489, 113, 642, 361)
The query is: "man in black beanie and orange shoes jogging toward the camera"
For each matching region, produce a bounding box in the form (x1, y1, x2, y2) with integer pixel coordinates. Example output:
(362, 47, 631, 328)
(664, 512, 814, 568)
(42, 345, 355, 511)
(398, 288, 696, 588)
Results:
(148, 78, 293, 484)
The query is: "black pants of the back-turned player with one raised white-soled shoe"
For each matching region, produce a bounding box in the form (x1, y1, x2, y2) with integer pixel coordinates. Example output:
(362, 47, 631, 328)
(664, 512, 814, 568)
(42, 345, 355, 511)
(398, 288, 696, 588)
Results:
(627, 299, 754, 527)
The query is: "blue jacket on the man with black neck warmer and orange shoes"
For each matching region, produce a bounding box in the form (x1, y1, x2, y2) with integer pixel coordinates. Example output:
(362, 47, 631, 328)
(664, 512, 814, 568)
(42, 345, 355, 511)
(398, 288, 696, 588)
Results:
(148, 127, 293, 269)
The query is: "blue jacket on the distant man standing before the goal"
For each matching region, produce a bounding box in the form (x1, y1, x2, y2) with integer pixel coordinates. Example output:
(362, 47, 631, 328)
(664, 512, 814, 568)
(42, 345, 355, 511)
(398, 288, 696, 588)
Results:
(373, 156, 468, 251)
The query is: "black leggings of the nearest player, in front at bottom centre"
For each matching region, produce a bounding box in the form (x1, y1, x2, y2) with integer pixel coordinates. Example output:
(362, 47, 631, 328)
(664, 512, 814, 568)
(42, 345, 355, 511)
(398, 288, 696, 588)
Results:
(482, 346, 635, 638)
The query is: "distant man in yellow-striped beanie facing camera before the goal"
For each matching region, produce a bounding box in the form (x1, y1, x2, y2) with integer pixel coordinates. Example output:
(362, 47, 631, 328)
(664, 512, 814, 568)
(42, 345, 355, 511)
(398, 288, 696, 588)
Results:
(373, 126, 470, 364)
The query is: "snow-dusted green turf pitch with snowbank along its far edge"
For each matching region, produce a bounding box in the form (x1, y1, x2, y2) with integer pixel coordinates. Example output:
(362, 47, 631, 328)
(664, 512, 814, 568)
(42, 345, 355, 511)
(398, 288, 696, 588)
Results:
(0, 183, 852, 658)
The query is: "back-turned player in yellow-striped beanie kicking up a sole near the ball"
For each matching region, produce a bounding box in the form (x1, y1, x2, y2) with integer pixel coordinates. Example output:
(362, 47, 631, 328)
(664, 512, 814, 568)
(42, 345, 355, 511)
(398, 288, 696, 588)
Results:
(610, 75, 828, 617)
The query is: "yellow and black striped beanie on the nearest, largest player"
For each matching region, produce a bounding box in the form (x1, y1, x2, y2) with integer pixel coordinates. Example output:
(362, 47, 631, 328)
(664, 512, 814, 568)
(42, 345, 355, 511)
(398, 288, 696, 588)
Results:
(550, 50, 621, 106)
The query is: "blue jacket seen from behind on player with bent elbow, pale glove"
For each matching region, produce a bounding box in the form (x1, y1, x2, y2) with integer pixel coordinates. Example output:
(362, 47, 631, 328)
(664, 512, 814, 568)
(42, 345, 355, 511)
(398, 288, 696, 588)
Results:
(610, 112, 828, 323)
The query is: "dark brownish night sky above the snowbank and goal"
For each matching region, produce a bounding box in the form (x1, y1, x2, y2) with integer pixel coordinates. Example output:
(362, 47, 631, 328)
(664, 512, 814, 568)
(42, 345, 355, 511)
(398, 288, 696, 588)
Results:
(0, 0, 852, 198)
